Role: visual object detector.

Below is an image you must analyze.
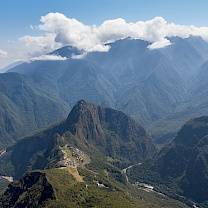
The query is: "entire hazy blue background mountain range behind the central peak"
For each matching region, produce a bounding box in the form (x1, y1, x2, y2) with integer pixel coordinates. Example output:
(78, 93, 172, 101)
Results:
(0, 37, 208, 148)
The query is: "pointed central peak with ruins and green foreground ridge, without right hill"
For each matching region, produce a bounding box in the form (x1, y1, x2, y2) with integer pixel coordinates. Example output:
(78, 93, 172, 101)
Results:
(0, 100, 186, 208)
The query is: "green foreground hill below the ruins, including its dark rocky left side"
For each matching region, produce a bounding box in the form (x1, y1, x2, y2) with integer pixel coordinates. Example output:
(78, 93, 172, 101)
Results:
(0, 168, 186, 208)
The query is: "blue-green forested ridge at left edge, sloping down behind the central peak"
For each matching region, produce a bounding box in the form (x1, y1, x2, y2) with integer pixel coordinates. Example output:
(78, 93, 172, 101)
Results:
(0, 73, 69, 148)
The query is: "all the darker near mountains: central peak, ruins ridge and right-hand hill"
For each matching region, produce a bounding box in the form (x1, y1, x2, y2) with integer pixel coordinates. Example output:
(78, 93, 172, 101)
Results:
(0, 100, 208, 207)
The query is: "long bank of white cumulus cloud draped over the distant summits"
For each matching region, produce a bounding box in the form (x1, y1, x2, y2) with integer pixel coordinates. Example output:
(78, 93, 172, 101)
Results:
(19, 13, 208, 58)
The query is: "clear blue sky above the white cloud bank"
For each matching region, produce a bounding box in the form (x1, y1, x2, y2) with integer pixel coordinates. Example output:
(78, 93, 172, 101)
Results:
(0, 0, 208, 68)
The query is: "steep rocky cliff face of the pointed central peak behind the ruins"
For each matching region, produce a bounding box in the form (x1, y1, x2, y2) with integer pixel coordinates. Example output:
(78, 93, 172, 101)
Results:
(67, 100, 156, 163)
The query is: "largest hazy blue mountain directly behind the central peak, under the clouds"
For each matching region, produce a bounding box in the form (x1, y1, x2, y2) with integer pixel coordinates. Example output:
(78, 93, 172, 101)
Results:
(7, 39, 186, 124)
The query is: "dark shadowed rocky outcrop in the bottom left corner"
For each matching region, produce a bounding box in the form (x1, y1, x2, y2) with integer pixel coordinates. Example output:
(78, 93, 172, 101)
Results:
(0, 172, 55, 207)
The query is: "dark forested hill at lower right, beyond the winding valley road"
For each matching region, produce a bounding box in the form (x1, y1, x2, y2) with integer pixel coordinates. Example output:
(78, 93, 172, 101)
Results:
(129, 116, 208, 207)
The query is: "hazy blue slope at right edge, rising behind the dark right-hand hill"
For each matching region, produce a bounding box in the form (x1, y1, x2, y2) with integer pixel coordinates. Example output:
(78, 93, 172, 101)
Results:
(149, 52, 208, 143)
